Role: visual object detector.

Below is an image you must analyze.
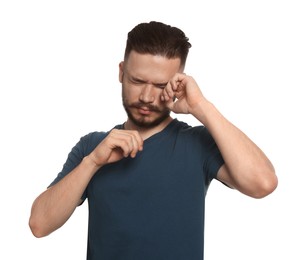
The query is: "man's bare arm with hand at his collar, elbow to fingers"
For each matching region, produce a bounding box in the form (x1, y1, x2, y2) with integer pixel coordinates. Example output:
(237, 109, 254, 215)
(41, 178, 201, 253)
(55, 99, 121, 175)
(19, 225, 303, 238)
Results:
(29, 129, 143, 237)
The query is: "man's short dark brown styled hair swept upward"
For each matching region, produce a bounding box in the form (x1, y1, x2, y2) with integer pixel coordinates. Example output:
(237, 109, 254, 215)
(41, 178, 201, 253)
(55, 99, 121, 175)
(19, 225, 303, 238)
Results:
(124, 21, 191, 66)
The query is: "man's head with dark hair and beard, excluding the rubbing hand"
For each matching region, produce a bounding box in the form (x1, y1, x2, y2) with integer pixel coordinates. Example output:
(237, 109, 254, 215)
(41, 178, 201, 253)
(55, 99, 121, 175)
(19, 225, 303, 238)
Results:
(119, 22, 191, 128)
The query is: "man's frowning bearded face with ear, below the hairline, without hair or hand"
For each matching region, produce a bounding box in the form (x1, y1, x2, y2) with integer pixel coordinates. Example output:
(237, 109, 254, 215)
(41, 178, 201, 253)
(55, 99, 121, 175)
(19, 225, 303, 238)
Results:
(119, 51, 181, 128)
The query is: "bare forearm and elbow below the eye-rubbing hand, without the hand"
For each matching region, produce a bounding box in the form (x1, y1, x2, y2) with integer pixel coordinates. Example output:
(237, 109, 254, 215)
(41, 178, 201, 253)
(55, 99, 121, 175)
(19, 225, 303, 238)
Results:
(192, 101, 277, 198)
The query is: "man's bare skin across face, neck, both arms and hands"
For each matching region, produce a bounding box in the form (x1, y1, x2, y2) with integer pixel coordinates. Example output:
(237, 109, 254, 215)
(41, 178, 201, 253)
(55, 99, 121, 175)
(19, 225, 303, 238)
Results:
(29, 51, 278, 237)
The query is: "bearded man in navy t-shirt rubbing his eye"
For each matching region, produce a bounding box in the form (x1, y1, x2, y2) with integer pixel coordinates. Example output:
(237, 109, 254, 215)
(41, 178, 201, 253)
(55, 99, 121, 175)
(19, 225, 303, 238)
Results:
(29, 22, 277, 260)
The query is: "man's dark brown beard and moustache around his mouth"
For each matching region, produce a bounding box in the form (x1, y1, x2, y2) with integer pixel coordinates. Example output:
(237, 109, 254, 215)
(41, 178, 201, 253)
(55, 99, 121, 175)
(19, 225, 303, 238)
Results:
(122, 97, 170, 128)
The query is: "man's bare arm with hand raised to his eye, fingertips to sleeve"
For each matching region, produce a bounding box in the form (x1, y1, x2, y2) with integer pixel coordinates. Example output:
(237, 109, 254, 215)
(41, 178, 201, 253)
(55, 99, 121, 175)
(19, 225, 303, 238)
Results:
(161, 73, 278, 198)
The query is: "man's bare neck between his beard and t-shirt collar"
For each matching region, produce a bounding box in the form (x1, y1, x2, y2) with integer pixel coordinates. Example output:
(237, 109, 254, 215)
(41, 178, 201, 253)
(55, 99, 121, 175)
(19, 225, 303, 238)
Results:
(124, 116, 173, 140)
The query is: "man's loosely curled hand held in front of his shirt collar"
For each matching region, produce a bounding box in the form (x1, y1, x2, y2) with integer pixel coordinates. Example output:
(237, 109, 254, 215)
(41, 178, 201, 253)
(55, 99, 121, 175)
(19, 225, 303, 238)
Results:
(89, 129, 143, 167)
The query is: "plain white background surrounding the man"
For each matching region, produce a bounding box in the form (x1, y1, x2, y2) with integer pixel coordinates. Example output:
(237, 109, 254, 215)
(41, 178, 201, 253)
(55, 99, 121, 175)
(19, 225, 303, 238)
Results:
(0, 0, 304, 260)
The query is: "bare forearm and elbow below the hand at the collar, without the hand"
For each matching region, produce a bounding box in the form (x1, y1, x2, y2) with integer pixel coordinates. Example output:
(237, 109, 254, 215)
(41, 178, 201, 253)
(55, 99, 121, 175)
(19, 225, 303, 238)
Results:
(29, 156, 98, 237)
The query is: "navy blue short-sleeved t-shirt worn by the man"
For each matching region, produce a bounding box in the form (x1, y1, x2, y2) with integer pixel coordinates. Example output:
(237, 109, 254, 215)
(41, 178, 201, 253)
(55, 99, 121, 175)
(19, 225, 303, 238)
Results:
(52, 119, 224, 260)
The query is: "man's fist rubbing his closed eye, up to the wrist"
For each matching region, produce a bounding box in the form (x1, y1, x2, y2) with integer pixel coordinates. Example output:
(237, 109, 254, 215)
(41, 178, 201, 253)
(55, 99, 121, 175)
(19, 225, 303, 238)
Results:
(161, 73, 205, 114)
